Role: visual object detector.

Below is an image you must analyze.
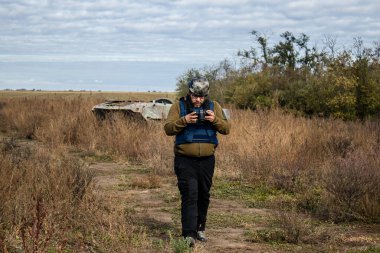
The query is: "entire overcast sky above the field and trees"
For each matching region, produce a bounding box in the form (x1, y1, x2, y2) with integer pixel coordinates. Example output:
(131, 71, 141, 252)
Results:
(0, 0, 380, 91)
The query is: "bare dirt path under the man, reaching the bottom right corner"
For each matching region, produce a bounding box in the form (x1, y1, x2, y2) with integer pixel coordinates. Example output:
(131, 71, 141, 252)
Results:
(90, 163, 380, 253)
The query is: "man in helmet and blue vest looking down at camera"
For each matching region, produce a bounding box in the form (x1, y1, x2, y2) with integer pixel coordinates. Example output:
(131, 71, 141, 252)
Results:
(164, 78, 230, 246)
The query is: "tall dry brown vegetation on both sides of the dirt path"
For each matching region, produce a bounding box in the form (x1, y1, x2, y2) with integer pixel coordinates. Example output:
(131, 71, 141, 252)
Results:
(0, 93, 380, 252)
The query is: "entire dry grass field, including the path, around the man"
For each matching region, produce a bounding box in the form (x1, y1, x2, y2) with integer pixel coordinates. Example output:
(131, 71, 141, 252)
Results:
(0, 91, 380, 253)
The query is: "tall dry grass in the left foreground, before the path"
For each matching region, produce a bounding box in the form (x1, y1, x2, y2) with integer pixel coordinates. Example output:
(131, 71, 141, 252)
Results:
(0, 138, 154, 253)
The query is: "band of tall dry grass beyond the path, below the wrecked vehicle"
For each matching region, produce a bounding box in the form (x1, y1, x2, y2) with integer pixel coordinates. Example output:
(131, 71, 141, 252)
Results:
(0, 97, 172, 168)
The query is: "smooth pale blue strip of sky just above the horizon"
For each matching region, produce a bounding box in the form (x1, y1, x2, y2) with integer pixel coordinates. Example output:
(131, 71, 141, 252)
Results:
(0, 61, 203, 92)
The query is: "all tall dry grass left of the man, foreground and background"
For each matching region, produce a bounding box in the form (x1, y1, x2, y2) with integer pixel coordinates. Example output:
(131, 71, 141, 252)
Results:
(0, 98, 162, 252)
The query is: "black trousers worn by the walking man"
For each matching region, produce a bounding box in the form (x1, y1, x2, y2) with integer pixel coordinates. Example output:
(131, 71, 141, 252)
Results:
(174, 155, 215, 238)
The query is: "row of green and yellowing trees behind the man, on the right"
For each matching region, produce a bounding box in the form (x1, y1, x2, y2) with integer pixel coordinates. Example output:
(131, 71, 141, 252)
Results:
(177, 31, 380, 120)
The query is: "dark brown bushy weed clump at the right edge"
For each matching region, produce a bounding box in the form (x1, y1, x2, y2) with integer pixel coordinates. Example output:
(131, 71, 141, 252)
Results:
(323, 150, 380, 222)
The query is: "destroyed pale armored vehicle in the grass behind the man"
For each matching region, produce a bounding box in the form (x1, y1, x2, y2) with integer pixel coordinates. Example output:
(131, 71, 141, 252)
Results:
(92, 98, 230, 121)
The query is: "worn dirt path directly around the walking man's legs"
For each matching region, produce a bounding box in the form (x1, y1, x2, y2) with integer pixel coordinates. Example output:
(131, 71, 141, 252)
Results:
(90, 163, 270, 252)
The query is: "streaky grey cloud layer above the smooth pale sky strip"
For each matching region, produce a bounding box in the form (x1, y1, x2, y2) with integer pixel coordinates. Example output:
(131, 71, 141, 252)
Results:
(0, 0, 380, 90)
